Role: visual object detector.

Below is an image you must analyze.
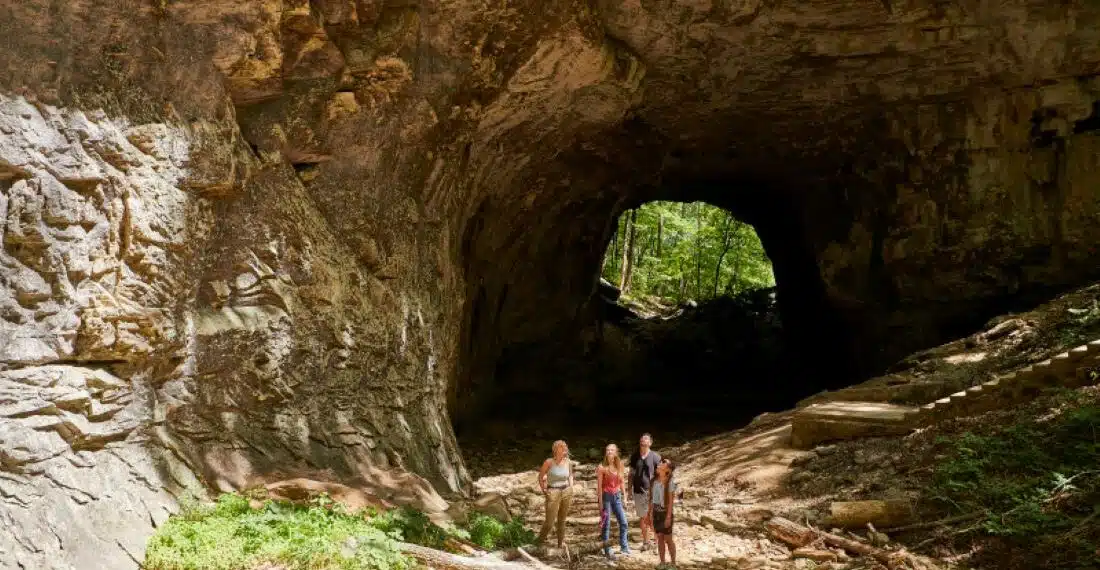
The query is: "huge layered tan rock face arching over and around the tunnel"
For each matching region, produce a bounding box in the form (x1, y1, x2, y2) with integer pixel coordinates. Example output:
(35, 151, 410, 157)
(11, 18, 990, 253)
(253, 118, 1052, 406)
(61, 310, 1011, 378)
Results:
(0, 0, 1100, 570)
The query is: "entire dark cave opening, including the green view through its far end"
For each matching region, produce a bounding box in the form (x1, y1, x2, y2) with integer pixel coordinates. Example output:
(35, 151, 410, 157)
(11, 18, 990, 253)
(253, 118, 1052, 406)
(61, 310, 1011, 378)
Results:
(449, 178, 857, 437)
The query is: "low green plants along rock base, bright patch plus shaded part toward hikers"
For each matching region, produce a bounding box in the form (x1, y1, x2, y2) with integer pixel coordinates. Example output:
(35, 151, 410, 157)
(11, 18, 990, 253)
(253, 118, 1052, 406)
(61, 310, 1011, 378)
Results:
(144, 493, 535, 570)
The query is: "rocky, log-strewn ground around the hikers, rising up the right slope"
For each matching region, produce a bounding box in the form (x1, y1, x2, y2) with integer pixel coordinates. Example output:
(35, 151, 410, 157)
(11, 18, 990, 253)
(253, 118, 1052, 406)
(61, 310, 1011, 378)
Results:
(464, 286, 1100, 569)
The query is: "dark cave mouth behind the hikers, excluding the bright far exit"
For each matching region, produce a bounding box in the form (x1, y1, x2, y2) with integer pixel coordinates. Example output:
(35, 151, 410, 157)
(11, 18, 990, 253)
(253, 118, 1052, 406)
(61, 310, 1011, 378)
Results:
(449, 179, 855, 437)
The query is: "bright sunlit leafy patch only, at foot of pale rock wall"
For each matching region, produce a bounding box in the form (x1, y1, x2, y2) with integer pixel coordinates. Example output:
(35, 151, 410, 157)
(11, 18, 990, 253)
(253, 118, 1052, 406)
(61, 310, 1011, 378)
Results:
(143, 493, 411, 570)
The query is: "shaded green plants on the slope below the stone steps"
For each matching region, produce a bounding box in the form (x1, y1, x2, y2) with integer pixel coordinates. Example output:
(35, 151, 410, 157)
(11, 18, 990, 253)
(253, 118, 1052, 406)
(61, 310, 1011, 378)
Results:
(930, 397, 1100, 569)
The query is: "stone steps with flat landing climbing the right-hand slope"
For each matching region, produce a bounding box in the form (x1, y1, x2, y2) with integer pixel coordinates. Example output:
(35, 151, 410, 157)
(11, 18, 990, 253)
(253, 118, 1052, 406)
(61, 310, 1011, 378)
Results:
(791, 339, 1100, 449)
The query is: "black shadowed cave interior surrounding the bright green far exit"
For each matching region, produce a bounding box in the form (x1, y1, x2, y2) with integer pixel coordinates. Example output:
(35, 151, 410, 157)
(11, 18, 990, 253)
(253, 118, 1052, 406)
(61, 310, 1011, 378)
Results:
(450, 178, 867, 438)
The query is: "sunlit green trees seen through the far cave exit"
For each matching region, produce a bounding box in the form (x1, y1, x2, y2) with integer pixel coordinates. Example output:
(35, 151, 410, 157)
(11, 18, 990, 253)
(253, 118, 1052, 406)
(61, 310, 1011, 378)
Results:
(603, 201, 776, 300)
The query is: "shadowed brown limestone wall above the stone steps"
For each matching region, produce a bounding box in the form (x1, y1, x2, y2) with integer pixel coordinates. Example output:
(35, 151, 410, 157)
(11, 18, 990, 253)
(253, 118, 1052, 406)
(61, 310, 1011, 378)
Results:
(807, 76, 1100, 364)
